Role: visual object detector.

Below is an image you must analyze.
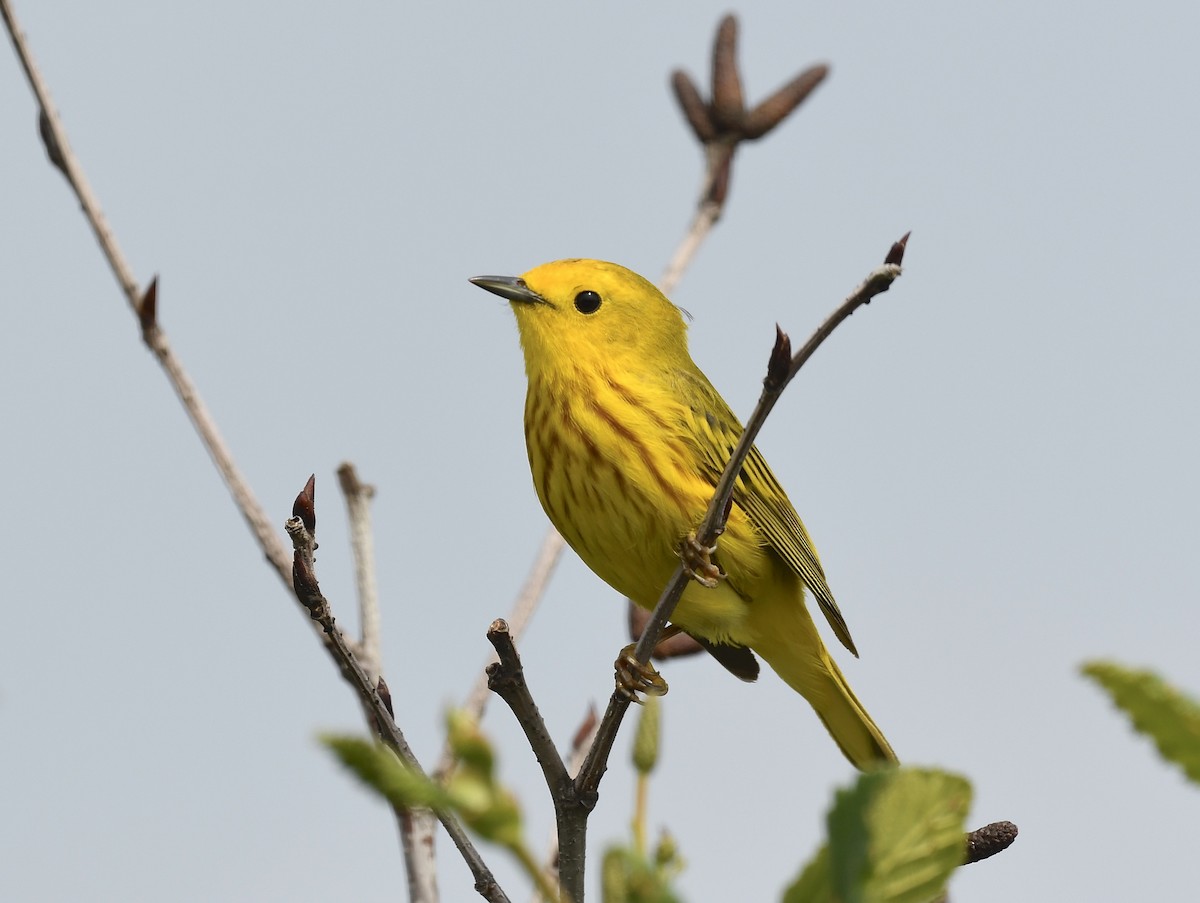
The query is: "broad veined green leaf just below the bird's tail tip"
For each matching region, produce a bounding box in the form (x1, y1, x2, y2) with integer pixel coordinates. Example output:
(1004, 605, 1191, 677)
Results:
(784, 769, 971, 903)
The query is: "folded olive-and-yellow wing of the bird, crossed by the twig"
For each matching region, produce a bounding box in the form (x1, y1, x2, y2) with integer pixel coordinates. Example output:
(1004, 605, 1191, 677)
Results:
(692, 375, 858, 656)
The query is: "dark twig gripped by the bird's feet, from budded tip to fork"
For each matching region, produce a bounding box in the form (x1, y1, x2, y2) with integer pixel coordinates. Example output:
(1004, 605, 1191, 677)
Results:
(575, 235, 908, 806)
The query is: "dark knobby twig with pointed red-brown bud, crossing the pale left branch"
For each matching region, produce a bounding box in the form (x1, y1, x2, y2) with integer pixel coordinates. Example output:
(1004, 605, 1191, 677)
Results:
(291, 509, 508, 903)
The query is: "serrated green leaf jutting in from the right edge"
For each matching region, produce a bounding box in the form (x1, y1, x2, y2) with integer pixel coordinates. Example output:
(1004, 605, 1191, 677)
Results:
(1080, 662, 1200, 784)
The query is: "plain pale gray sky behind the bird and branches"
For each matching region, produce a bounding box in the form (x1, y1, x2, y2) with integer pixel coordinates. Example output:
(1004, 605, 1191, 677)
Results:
(0, 0, 1200, 903)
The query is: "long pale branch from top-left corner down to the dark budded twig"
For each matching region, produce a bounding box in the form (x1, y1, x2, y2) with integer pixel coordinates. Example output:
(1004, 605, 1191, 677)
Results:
(0, 0, 292, 588)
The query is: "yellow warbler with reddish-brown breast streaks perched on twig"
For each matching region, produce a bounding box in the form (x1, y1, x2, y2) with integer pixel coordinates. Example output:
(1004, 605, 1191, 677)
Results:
(472, 259, 895, 769)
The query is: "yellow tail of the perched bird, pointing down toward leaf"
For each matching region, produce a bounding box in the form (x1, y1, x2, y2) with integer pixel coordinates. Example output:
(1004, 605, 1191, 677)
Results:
(748, 585, 898, 769)
